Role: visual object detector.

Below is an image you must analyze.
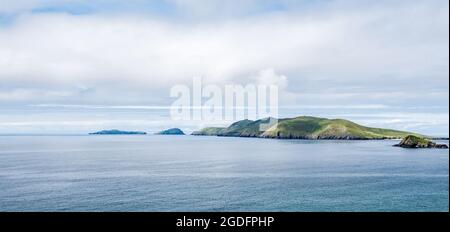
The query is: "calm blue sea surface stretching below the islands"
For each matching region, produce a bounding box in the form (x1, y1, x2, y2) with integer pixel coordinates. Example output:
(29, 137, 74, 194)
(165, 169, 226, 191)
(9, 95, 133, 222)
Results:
(0, 136, 449, 211)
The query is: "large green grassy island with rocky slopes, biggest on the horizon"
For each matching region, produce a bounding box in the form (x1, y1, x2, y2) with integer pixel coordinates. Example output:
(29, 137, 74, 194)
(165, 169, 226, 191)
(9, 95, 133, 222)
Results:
(192, 116, 426, 140)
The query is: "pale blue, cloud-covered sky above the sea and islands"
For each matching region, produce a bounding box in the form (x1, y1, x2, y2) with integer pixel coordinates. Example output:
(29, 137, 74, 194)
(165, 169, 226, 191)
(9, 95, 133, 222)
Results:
(0, 0, 449, 136)
